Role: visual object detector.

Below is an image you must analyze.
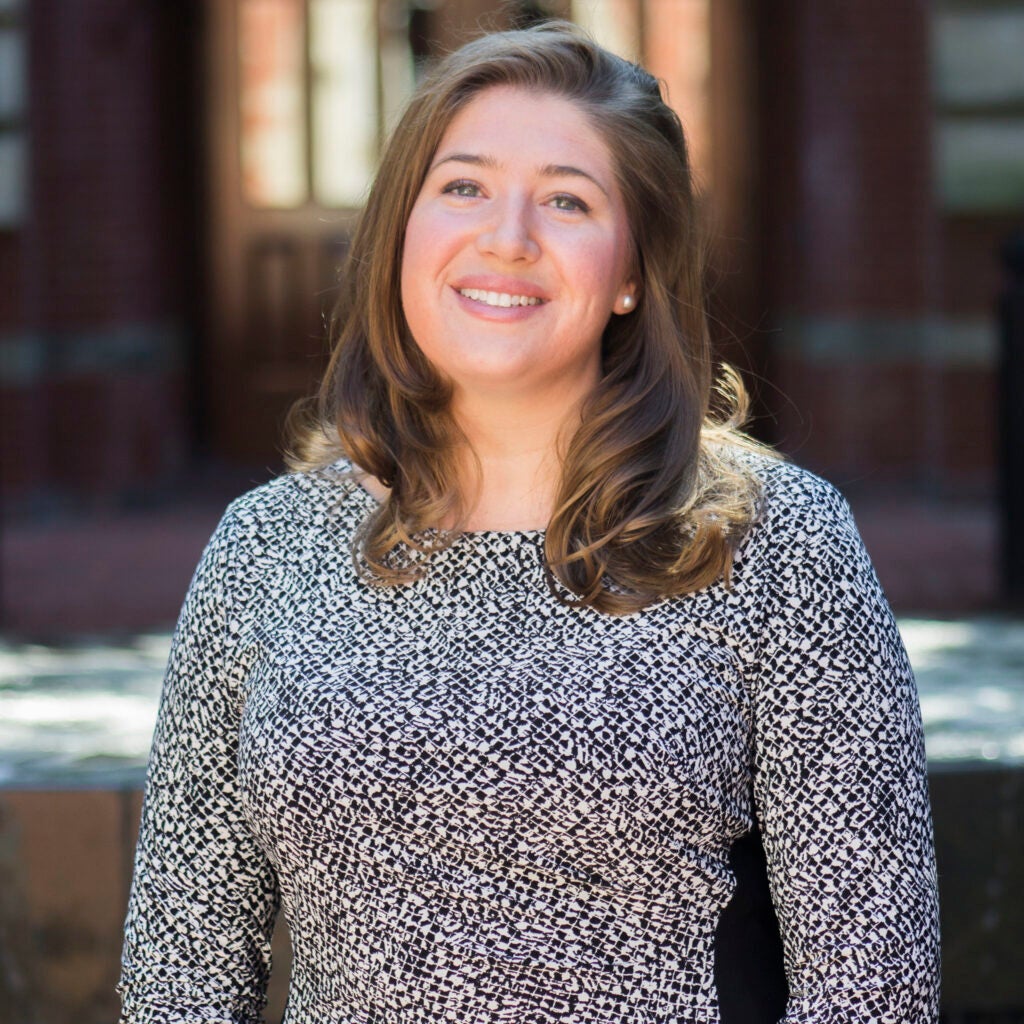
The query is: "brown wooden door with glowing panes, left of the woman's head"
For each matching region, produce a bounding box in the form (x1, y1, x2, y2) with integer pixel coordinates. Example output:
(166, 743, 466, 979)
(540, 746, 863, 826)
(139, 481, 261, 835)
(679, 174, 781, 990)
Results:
(205, 0, 399, 465)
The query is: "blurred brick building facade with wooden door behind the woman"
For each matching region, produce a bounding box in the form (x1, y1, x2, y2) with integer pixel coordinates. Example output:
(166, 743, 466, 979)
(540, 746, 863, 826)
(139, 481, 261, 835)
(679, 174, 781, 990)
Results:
(0, 0, 1024, 569)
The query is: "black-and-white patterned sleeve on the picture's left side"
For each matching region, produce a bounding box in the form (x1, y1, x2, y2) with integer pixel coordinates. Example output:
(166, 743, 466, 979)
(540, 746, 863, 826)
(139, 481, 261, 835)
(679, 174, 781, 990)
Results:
(118, 510, 279, 1024)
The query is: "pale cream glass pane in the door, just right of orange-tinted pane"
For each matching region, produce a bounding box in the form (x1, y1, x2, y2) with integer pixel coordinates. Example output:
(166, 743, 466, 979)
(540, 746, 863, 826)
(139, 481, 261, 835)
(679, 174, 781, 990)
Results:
(309, 0, 378, 206)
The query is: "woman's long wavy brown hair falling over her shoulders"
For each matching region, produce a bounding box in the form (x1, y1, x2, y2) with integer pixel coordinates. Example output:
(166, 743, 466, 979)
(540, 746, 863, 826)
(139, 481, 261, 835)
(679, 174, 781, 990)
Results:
(289, 23, 770, 613)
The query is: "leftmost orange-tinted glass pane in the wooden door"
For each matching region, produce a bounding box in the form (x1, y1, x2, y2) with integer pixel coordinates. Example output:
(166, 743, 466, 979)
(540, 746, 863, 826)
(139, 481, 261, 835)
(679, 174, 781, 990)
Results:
(239, 0, 308, 207)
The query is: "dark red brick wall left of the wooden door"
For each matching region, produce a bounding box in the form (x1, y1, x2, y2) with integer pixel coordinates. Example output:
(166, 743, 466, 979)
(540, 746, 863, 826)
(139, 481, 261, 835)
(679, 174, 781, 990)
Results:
(0, 0, 194, 497)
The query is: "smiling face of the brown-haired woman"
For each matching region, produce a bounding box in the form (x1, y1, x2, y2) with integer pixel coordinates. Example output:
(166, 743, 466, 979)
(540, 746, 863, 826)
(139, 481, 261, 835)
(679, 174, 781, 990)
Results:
(401, 86, 636, 406)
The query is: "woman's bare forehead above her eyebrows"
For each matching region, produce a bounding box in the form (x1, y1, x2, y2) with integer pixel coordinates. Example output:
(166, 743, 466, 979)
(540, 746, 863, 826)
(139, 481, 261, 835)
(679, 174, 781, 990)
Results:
(435, 85, 613, 170)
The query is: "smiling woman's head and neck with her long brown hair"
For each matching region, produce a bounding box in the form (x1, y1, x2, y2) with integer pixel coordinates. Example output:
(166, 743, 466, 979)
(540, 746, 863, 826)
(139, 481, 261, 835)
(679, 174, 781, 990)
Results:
(284, 27, 760, 613)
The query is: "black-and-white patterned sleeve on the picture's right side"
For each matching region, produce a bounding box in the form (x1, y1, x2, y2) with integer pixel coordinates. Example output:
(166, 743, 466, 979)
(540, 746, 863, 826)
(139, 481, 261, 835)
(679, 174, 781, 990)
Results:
(754, 481, 939, 1024)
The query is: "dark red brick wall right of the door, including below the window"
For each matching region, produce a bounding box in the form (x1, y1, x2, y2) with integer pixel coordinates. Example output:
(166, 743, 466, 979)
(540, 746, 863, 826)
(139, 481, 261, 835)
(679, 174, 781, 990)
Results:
(759, 0, 1007, 496)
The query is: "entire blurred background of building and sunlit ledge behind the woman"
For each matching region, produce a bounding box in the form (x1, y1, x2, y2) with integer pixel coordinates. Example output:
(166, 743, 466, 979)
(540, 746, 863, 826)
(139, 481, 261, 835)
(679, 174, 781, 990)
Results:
(0, 0, 1024, 1024)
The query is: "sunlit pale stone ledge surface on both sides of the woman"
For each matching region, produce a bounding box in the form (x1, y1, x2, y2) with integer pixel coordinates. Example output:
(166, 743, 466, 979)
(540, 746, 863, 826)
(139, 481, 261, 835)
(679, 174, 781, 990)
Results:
(0, 617, 1024, 787)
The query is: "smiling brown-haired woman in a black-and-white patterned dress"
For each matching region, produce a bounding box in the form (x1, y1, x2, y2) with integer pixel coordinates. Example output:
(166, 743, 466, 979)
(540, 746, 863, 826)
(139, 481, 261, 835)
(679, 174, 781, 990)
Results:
(121, 18, 938, 1024)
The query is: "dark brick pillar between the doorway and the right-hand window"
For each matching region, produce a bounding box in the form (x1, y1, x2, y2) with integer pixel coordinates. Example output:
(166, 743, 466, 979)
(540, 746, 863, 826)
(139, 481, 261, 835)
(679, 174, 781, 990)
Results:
(759, 0, 935, 482)
